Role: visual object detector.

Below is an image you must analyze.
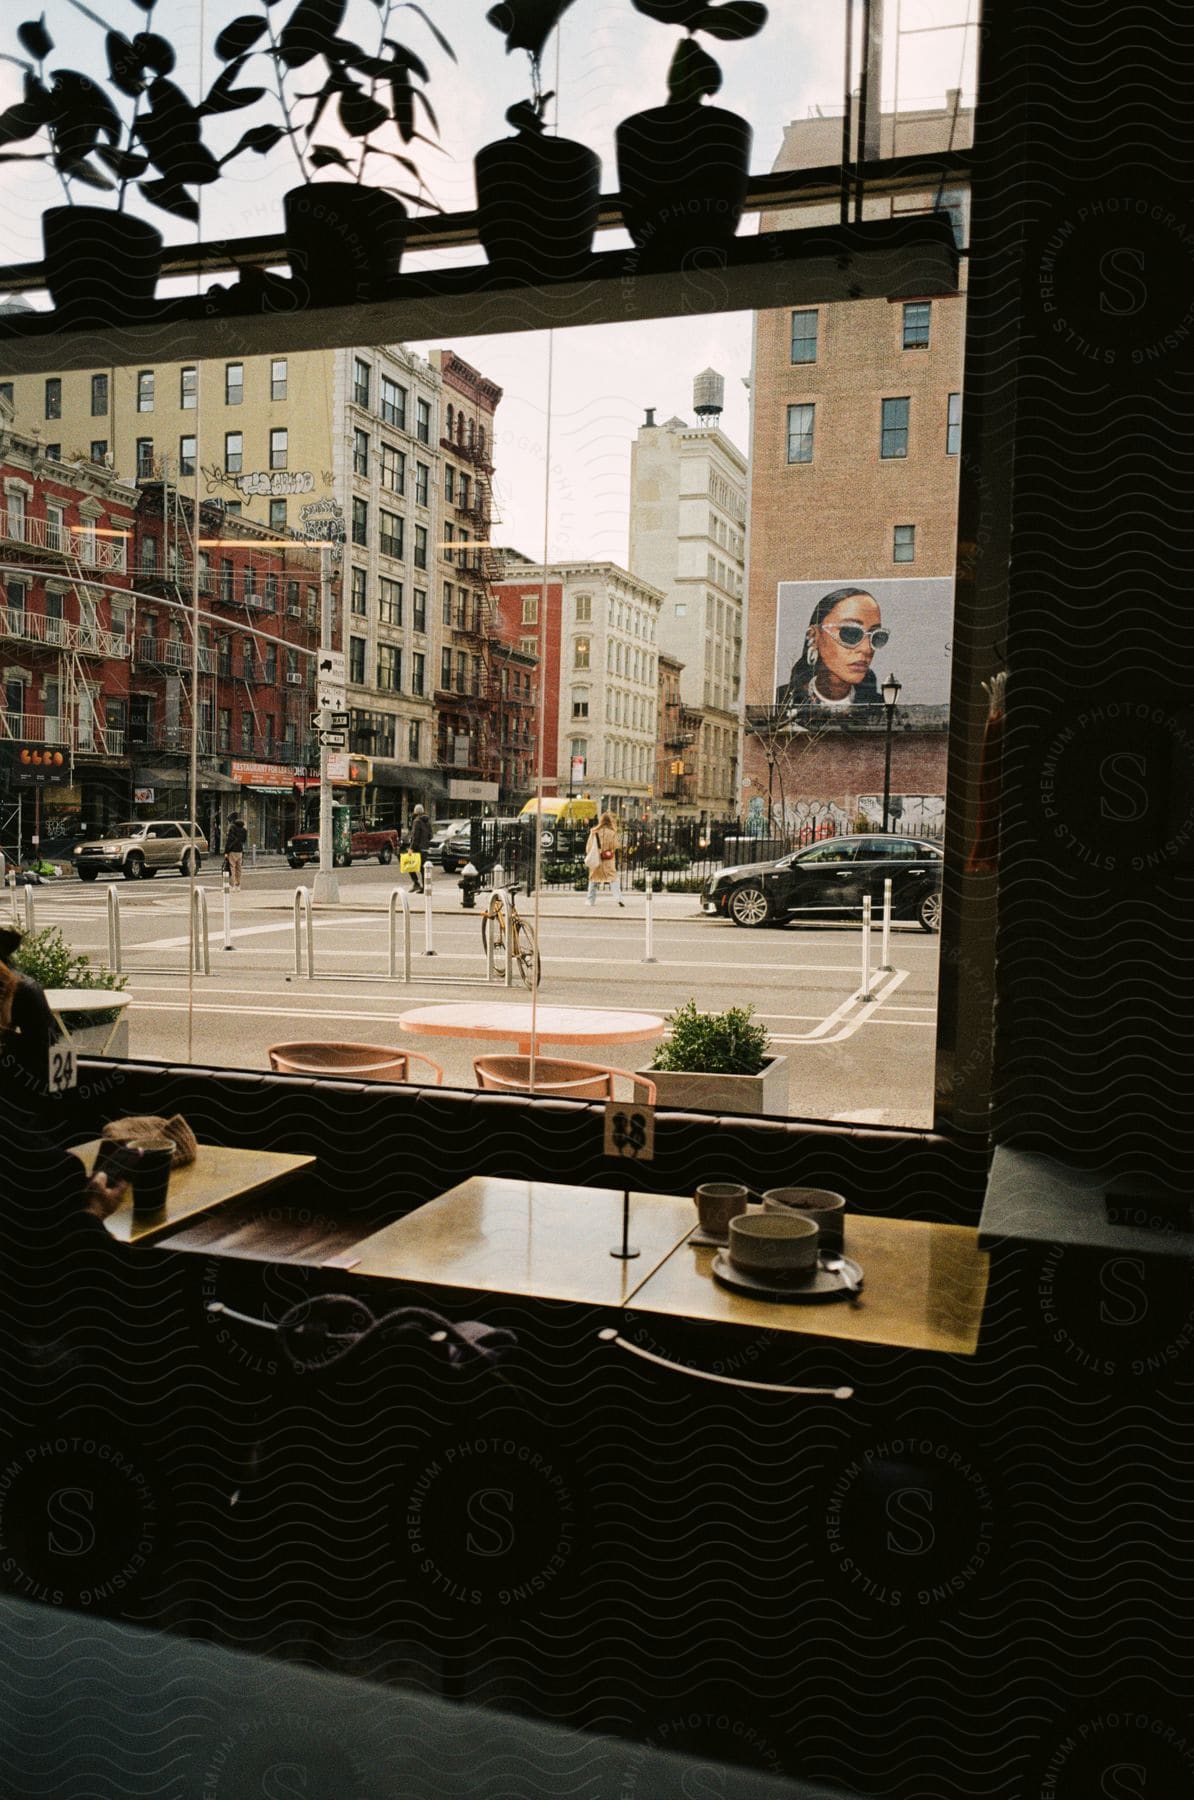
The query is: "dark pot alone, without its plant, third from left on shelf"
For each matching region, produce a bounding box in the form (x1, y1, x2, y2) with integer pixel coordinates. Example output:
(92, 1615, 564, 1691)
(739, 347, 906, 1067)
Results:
(474, 131, 602, 281)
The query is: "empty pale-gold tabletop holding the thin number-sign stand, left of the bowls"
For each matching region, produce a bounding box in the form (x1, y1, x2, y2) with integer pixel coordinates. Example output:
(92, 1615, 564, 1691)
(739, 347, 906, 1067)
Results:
(345, 1175, 697, 1307)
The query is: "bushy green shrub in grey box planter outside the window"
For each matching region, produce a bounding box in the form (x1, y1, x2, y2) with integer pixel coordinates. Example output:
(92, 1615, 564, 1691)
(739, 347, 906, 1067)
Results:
(638, 1001, 789, 1114)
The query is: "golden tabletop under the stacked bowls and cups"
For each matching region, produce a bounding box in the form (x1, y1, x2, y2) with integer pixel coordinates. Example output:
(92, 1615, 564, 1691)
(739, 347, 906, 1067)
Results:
(630, 1211, 989, 1355)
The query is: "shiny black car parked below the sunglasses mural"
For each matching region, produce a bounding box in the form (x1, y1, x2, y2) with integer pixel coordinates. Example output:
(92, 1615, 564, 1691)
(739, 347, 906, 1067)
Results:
(701, 833, 942, 931)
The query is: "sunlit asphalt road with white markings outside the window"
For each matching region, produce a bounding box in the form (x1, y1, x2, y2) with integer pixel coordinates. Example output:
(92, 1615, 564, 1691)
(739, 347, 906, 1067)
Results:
(14, 859, 938, 1125)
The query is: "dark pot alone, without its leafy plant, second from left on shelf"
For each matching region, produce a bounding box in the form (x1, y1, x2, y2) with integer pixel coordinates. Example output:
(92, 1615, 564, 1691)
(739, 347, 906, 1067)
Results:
(283, 182, 407, 306)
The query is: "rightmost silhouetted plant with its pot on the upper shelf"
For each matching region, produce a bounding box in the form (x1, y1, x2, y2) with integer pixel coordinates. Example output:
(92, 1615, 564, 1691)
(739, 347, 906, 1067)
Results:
(616, 0, 767, 265)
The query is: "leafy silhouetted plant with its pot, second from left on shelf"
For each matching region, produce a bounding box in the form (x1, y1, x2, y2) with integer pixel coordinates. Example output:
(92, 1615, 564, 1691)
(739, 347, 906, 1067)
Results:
(214, 0, 456, 306)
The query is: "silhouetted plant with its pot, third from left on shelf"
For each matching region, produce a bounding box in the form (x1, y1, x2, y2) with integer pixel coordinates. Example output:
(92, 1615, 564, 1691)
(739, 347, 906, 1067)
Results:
(474, 0, 602, 279)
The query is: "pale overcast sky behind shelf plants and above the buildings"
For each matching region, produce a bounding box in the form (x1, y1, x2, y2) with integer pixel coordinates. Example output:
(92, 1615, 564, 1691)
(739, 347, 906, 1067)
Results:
(0, 0, 978, 562)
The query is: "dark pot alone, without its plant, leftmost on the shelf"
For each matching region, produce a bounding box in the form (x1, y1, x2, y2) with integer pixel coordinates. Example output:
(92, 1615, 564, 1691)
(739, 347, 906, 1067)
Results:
(41, 207, 162, 324)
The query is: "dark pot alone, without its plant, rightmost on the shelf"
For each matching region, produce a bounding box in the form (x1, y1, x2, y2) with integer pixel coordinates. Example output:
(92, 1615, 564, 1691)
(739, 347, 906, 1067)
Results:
(614, 101, 751, 266)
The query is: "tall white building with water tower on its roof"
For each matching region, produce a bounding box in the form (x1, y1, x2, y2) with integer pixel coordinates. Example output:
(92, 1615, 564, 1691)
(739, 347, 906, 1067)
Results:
(629, 369, 747, 815)
